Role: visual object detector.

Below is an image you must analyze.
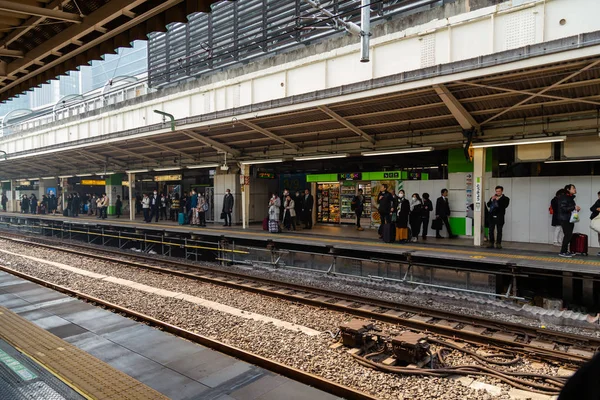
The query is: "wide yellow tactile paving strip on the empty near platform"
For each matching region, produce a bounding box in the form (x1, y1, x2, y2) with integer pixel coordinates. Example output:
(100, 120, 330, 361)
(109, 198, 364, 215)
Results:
(0, 307, 168, 400)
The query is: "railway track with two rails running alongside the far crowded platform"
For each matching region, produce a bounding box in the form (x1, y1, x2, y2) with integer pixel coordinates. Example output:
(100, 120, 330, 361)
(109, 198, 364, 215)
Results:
(0, 233, 600, 366)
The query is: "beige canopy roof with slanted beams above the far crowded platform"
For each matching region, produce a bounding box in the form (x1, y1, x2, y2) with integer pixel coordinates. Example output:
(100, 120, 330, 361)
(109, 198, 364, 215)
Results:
(0, 46, 600, 179)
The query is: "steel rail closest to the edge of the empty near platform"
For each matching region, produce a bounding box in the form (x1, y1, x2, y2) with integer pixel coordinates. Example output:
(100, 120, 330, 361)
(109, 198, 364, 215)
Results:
(0, 265, 377, 400)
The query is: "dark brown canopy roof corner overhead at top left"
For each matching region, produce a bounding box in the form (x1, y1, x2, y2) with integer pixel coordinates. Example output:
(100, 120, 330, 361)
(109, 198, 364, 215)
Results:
(0, 0, 224, 101)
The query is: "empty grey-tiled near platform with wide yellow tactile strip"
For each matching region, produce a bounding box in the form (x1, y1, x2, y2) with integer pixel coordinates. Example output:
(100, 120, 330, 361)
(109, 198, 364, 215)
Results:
(0, 272, 337, 400)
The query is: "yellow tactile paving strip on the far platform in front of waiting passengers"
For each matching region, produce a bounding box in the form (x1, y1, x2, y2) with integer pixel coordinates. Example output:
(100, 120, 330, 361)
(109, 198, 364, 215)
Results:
(4, 214, 600, 267)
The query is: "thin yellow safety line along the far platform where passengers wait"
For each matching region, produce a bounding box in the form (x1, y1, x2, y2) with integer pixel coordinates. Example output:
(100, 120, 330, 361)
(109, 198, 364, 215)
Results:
(5, 214, 600, 267)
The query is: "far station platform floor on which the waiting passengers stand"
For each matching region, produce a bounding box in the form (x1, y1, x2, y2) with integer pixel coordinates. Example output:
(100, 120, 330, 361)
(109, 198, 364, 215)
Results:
(0, 213, 600, 277)
